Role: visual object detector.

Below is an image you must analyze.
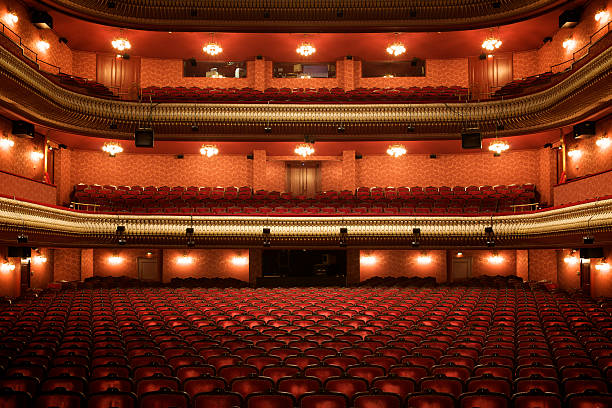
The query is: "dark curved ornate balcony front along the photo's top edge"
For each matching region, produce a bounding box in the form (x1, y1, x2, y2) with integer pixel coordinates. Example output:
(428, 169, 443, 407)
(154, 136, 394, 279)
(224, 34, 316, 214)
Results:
(41, 0, 564, 32)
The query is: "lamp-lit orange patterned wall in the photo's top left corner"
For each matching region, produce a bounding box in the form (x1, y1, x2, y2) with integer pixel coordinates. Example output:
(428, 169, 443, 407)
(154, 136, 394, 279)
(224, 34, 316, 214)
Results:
(0, 1, 72, 74)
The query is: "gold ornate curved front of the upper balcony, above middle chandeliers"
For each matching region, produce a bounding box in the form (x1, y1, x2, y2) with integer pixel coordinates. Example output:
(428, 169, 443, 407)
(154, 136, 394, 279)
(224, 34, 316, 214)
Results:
(0, 42, 612, 140)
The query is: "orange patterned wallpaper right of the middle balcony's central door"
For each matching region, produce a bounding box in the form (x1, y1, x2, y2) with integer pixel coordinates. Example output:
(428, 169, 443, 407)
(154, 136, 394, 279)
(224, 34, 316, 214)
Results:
(357, 150, 538, 187)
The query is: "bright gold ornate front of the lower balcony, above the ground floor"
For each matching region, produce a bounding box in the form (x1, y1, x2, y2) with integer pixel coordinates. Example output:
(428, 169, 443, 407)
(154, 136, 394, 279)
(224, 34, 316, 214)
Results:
(0, 198, 612, 247)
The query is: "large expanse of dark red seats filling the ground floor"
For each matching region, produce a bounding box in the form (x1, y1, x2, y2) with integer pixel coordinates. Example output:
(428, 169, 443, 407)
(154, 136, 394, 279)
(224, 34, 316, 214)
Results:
(0, 286, 612, 408)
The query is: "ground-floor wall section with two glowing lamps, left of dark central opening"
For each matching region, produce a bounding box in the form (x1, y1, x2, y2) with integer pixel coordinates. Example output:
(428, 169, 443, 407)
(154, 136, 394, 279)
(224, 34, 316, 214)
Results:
(163, 249, 249, 282)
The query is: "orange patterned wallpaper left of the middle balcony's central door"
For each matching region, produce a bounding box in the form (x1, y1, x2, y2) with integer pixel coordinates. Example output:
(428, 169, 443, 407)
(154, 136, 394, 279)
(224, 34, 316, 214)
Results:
(70, 150, 251, 187)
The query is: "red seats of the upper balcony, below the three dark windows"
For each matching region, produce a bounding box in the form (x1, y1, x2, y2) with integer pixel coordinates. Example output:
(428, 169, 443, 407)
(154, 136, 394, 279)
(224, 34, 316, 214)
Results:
(142, 86, 468, 103)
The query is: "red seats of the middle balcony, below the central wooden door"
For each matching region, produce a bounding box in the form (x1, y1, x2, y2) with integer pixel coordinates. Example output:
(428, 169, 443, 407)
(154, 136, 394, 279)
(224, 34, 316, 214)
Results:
(73, 184, 537, 215)
